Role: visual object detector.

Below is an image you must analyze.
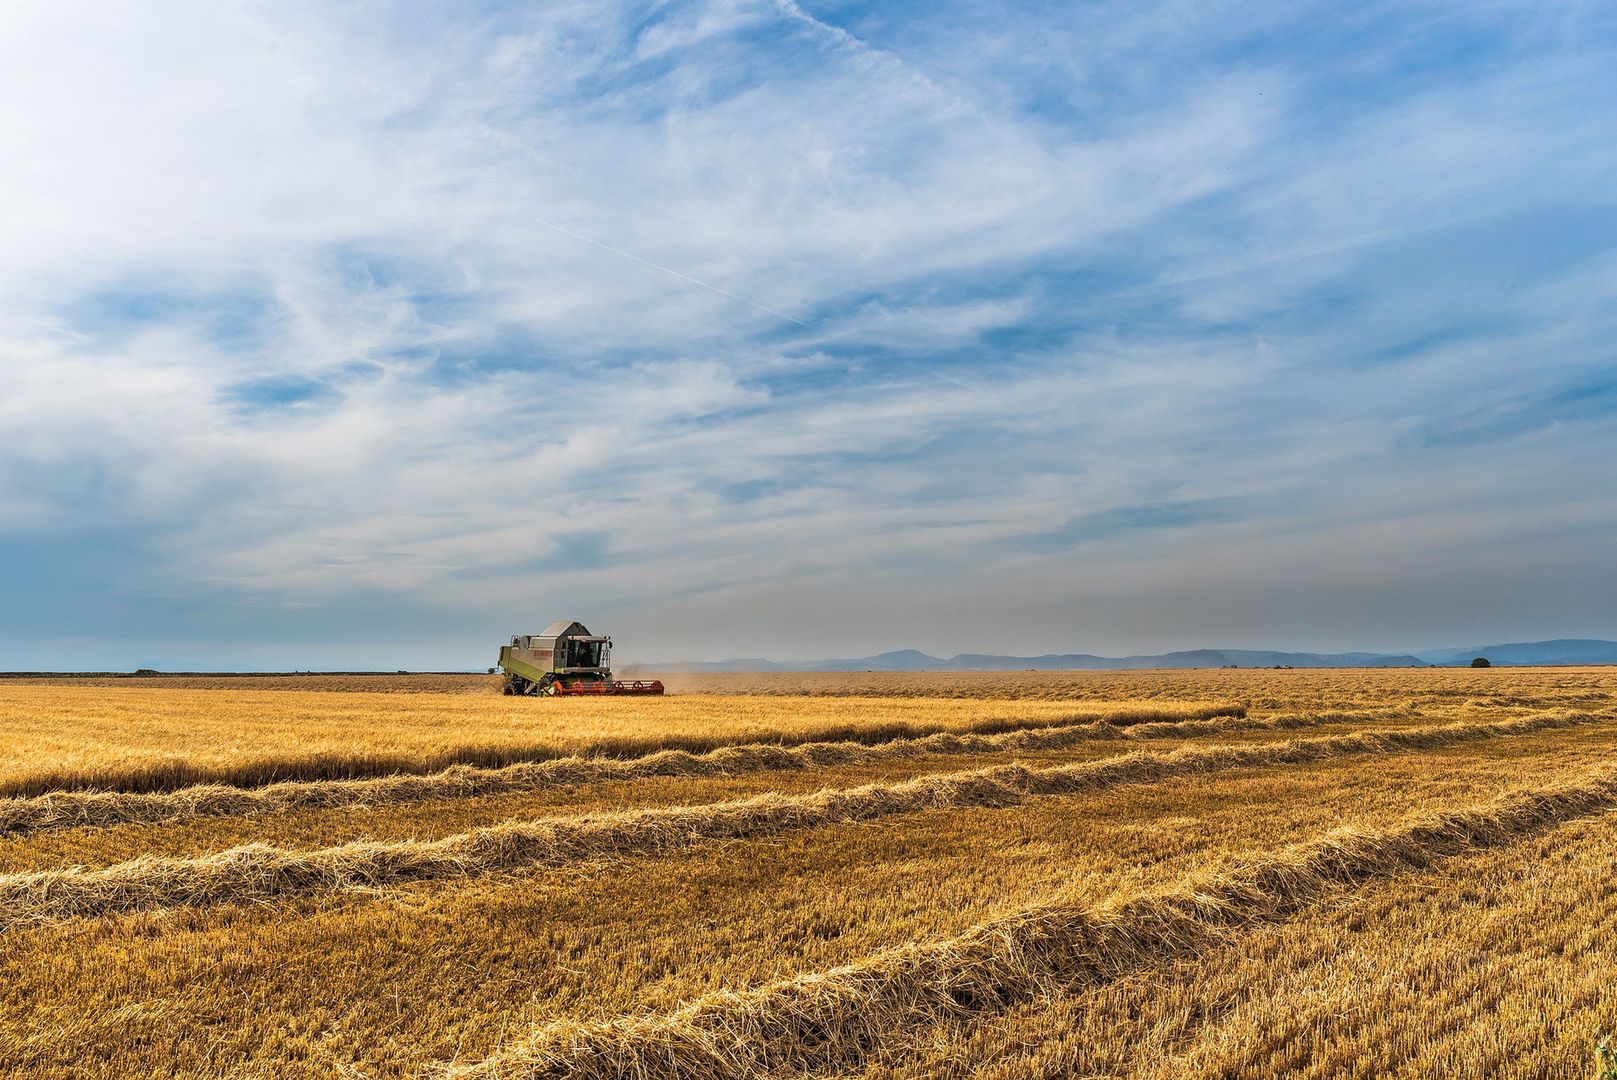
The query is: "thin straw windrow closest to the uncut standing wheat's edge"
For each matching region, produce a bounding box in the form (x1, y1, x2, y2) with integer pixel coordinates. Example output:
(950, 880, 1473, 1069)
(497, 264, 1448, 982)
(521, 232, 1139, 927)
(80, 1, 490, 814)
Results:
(0, 713, 1384, 834)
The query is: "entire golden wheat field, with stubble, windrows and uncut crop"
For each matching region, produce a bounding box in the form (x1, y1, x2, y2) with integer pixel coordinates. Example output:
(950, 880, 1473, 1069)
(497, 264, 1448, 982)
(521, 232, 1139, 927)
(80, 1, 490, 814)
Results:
(0, 668, 1617, 1080)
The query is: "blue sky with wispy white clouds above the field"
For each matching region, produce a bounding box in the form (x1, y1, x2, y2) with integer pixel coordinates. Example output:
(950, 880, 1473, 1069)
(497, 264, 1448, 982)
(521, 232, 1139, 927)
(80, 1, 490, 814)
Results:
(0, 0, 1617, 669)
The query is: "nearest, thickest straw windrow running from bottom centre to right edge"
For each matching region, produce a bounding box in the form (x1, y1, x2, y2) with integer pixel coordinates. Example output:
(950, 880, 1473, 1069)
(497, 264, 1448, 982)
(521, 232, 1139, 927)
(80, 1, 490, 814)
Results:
(450, 770, 1617, 1080)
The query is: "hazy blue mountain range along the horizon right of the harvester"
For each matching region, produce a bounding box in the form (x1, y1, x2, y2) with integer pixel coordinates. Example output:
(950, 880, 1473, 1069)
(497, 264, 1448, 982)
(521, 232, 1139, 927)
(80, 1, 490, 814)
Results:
(659, 639, 1617, 671)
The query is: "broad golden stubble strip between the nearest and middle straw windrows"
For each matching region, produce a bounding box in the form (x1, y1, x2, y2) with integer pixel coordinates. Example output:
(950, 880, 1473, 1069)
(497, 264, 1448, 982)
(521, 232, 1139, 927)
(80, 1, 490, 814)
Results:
(0, 717, 1614, 1075)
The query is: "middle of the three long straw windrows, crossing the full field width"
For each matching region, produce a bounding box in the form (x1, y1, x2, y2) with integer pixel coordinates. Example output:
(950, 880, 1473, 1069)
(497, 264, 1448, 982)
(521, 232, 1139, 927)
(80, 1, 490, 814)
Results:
(0, 713, 1611, 930)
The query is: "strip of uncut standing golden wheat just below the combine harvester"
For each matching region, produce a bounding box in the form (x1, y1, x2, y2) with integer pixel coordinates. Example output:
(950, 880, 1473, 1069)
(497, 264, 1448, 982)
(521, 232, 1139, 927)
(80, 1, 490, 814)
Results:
(0, 687, 1245, 797)
